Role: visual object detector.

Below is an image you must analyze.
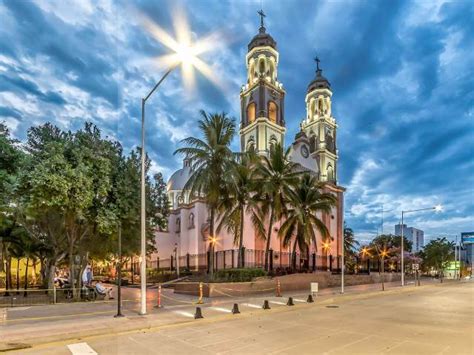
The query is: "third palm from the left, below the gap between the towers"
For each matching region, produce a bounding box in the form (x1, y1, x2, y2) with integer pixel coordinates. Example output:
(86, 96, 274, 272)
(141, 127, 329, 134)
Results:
(255, 143, 300, 270)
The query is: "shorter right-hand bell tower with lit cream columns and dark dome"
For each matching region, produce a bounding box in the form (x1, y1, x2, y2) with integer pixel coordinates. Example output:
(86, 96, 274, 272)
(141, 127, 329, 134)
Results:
(301, 57, 338, 184)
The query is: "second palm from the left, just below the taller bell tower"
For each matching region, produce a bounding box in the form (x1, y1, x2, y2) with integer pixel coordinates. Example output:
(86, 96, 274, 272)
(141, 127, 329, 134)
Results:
(217, 153, 265, 268)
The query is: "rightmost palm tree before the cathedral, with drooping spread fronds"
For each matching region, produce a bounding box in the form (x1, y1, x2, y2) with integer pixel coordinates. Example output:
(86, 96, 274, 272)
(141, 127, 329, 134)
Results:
(278, 173, 336, 268)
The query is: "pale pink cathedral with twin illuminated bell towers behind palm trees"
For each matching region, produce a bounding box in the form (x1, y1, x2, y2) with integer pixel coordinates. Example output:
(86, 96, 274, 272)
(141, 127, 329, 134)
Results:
(156, 12, 344, 270)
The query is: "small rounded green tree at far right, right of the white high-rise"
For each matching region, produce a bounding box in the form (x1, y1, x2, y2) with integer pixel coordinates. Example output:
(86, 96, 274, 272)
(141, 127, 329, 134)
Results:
(421, 237, 454, 282)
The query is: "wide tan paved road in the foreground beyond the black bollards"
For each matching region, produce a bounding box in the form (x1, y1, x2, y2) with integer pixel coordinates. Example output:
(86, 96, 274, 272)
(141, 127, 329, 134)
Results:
(12, 282, 474, 355)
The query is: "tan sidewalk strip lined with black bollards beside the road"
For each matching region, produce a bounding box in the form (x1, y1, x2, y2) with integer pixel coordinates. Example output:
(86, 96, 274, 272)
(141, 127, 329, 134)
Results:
(0, 282, 446, 349)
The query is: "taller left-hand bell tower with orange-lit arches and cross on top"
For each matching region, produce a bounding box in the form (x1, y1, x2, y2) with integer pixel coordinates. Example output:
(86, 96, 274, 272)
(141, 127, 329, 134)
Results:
(240, 10, 286, 155)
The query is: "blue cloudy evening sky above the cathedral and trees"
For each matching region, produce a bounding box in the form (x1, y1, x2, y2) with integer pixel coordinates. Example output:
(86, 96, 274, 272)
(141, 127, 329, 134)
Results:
(0, 0, 474, 241)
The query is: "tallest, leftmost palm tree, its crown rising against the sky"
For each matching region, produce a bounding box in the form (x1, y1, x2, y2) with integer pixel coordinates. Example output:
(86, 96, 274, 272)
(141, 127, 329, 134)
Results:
(175, 110, 235, 278)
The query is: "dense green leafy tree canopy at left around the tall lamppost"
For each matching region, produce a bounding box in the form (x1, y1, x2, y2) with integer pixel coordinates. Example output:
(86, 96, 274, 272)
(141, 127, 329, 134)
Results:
(0, 123, 168, 290)
